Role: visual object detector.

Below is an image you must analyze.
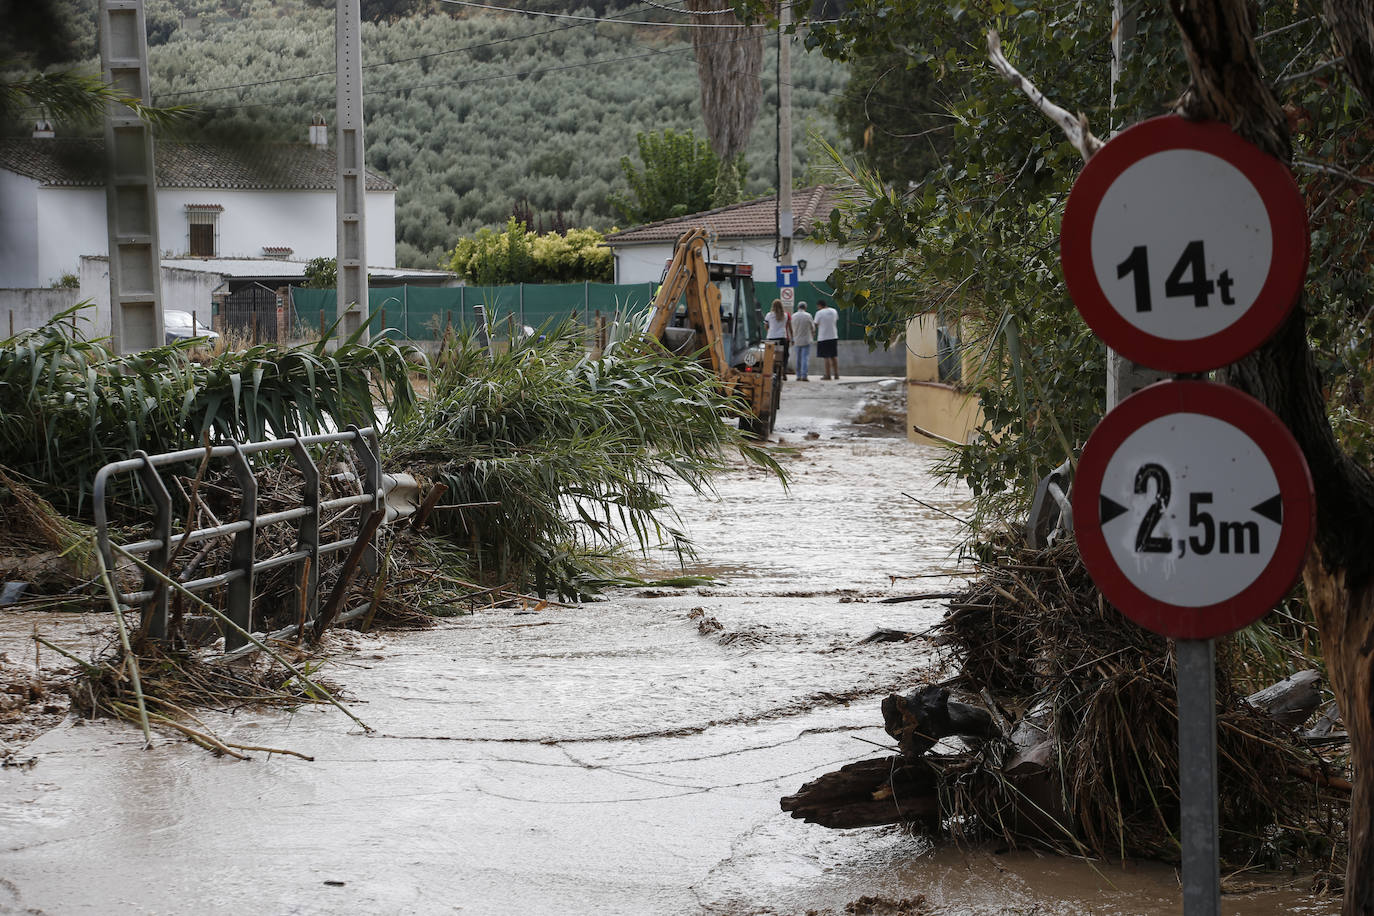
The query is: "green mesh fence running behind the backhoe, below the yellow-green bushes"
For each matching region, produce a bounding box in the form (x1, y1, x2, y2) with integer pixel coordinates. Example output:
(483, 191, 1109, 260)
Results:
(291, 283, 863, 341)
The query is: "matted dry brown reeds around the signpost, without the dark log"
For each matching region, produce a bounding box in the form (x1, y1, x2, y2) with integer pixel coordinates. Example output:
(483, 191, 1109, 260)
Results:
(934, 536, 1349, 865)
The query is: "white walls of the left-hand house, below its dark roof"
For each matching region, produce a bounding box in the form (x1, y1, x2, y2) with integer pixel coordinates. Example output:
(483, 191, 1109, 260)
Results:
(20, 182, 396, 287)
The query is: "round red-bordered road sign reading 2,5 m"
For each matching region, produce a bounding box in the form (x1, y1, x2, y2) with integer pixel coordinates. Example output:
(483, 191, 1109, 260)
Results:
(1073, 382, 1314, 639)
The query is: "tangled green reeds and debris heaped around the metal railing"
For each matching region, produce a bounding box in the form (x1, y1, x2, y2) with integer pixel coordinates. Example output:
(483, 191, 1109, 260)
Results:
(0, 313, 782, 754)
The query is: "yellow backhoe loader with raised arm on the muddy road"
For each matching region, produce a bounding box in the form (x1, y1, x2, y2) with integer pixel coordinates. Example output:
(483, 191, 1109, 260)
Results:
(649, 229, 783, 438)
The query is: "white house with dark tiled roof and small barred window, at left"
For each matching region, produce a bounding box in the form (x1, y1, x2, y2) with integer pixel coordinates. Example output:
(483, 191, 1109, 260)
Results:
(0, 137, 396, 288)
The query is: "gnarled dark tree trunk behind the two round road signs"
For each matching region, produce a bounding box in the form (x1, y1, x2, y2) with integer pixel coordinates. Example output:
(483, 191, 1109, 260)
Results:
(1171, 0, 1374, 916)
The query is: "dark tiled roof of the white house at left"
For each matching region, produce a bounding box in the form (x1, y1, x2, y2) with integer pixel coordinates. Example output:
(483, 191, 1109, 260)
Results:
(0, 139, 396, 191)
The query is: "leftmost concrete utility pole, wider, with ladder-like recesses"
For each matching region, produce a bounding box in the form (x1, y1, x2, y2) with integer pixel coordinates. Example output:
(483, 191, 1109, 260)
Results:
(100, 0, 162, 353)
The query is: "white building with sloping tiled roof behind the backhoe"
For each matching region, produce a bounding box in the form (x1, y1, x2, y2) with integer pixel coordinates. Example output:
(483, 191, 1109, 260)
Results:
(606, 185, 844, 283)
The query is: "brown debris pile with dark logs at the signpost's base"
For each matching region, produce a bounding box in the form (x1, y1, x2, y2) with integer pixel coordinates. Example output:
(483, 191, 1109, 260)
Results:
(783, 544, 1351, 867)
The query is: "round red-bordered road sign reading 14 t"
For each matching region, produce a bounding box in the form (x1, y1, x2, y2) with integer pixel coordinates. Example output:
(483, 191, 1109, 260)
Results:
(1059, 115, 1308, 372)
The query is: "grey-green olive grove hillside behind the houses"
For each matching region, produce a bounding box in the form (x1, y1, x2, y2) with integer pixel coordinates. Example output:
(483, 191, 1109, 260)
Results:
(48, 0, 845, 266)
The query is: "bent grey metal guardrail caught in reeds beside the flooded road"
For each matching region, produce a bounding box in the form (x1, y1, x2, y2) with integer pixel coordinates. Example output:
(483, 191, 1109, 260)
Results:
(95, 426, 382, 651)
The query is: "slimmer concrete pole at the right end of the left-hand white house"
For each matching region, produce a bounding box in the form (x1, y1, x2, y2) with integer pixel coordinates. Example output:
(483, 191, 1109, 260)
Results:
(334, 0, 371, 342)
